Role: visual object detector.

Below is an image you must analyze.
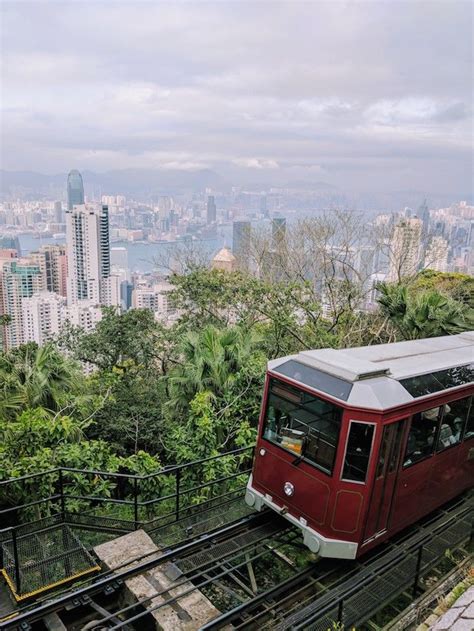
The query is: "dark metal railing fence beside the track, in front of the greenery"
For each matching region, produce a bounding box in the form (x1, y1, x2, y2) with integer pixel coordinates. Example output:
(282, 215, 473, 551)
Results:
(0, 447, 253, 600)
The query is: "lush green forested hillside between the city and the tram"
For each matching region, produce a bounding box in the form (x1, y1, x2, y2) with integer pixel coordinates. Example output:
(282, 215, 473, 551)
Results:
(0, 269, 474, 501)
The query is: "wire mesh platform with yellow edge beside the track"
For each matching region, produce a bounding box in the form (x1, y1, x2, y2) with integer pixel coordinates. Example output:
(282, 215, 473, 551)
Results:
(2, 524, 100, 600)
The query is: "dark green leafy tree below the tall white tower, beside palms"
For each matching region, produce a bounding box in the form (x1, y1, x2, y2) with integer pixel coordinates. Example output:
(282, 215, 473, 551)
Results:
(58, 309, 179, 456)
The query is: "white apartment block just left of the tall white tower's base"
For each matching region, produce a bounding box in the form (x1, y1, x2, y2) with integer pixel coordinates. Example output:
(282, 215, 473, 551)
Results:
(22, 291, 66, 346)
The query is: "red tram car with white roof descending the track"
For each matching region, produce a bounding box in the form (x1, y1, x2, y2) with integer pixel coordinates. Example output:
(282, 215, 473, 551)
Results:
(245, 332, 474, 559)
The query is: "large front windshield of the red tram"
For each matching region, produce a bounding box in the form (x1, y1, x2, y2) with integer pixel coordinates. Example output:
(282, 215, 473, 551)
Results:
(263, 379, 342, 474)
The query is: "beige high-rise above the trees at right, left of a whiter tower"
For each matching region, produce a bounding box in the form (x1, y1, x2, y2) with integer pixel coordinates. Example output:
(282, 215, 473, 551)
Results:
(387, 217, 423, 281)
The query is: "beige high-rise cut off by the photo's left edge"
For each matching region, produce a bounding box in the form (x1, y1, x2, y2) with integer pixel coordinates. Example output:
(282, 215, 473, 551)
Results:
(0, 258, 44, 349)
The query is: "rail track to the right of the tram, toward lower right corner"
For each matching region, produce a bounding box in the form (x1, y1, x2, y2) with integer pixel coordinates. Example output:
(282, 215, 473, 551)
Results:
(202, 497, 474, 631)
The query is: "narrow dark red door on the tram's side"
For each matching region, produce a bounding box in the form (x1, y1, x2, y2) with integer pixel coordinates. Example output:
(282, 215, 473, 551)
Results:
(364, 419, 406, 541)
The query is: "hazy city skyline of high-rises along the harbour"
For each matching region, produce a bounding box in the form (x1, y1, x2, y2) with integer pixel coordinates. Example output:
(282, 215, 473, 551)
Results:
(0, 165, 474, 349)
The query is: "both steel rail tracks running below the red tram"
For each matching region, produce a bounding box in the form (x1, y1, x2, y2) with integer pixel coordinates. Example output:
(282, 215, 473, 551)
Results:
(0, 497, 473, 631)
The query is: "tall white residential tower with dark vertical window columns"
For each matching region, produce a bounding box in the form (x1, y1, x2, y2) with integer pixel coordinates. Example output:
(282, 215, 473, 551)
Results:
(66, 204, 120, 305)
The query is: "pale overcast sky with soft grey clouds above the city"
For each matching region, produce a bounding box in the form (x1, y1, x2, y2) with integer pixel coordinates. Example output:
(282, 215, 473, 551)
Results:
(1, 0, 473, 193)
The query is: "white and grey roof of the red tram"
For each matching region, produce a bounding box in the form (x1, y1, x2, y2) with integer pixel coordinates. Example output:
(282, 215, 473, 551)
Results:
(268, 331, 474, 410)
